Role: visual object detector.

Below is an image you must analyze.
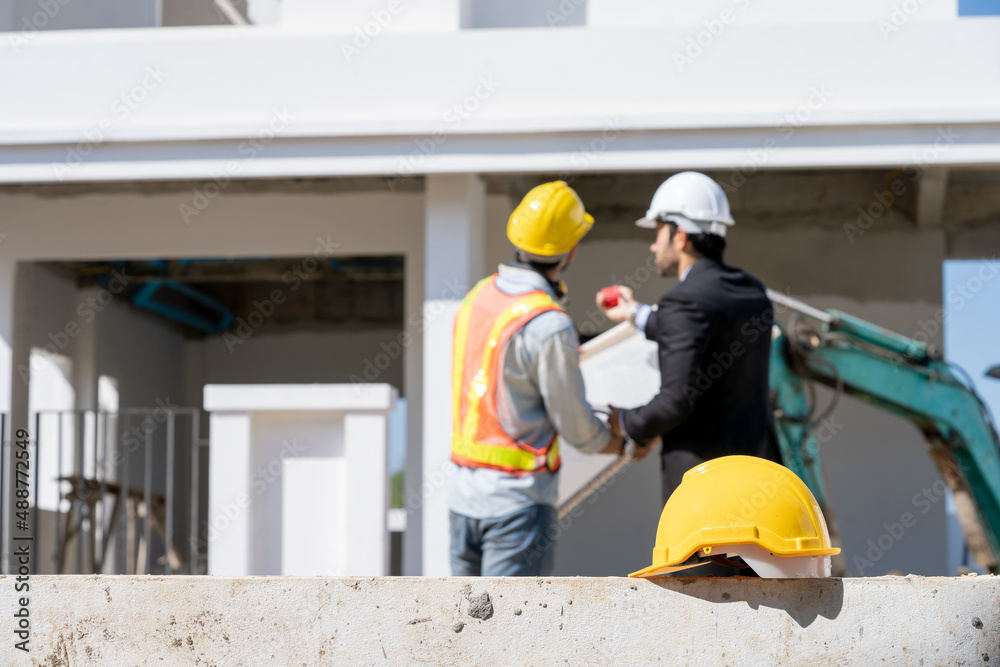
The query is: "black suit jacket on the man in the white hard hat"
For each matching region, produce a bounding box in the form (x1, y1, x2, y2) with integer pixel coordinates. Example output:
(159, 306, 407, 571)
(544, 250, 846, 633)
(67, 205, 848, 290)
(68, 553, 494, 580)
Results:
(624, 258, 781, 463)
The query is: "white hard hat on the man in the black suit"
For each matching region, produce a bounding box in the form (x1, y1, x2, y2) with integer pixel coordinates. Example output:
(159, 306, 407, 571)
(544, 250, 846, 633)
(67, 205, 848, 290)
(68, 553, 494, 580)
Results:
(635, 171, 736, 236)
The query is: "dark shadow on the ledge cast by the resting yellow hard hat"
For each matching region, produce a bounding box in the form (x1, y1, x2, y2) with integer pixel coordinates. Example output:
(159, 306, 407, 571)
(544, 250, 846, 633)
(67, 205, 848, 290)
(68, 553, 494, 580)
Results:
(637, 577, 844, 628)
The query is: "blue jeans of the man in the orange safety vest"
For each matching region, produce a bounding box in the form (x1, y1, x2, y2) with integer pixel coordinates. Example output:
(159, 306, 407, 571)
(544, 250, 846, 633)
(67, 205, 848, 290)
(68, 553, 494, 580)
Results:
(451, 505, 558, 577)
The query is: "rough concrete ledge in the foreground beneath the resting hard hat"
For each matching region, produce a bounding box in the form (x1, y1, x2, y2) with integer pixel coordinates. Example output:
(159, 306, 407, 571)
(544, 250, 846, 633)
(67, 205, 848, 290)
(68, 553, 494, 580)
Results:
(0, 576, 1000, 667)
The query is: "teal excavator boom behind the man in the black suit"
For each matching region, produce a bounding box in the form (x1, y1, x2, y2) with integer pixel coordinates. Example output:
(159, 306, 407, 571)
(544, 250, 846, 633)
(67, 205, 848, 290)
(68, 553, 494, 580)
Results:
(768, 290, 1000, 572)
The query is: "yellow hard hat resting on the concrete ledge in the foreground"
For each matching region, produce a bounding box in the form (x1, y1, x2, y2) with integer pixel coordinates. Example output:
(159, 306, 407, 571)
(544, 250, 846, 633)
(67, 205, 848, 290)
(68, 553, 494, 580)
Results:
(629, 456, 840, 577)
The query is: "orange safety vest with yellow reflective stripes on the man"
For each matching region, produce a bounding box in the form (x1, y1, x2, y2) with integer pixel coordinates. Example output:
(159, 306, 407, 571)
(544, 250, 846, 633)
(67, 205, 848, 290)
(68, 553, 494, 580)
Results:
(451, 274, 565, 475)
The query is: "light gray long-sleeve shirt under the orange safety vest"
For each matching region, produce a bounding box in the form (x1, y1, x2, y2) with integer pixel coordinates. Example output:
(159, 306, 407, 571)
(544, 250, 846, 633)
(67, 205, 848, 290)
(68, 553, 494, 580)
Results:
(448, 266, 611, 519)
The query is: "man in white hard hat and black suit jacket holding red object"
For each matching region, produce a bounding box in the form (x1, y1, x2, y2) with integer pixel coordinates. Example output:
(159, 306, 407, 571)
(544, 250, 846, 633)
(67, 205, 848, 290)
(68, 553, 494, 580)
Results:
(597, 171, 781, 502)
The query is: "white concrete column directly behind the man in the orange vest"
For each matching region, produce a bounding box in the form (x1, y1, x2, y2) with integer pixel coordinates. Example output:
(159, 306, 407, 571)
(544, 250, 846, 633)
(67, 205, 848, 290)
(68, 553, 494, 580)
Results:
(420, 174, 486, 576)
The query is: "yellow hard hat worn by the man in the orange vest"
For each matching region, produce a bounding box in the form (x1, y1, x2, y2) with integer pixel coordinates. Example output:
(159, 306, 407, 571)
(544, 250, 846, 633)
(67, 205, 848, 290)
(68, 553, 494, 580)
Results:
(507, 181, 594, 258)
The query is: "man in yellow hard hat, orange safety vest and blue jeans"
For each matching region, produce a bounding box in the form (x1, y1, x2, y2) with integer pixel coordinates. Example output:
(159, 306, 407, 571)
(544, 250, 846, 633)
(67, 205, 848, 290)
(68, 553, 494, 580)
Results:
(448, 181, 649, 576)
